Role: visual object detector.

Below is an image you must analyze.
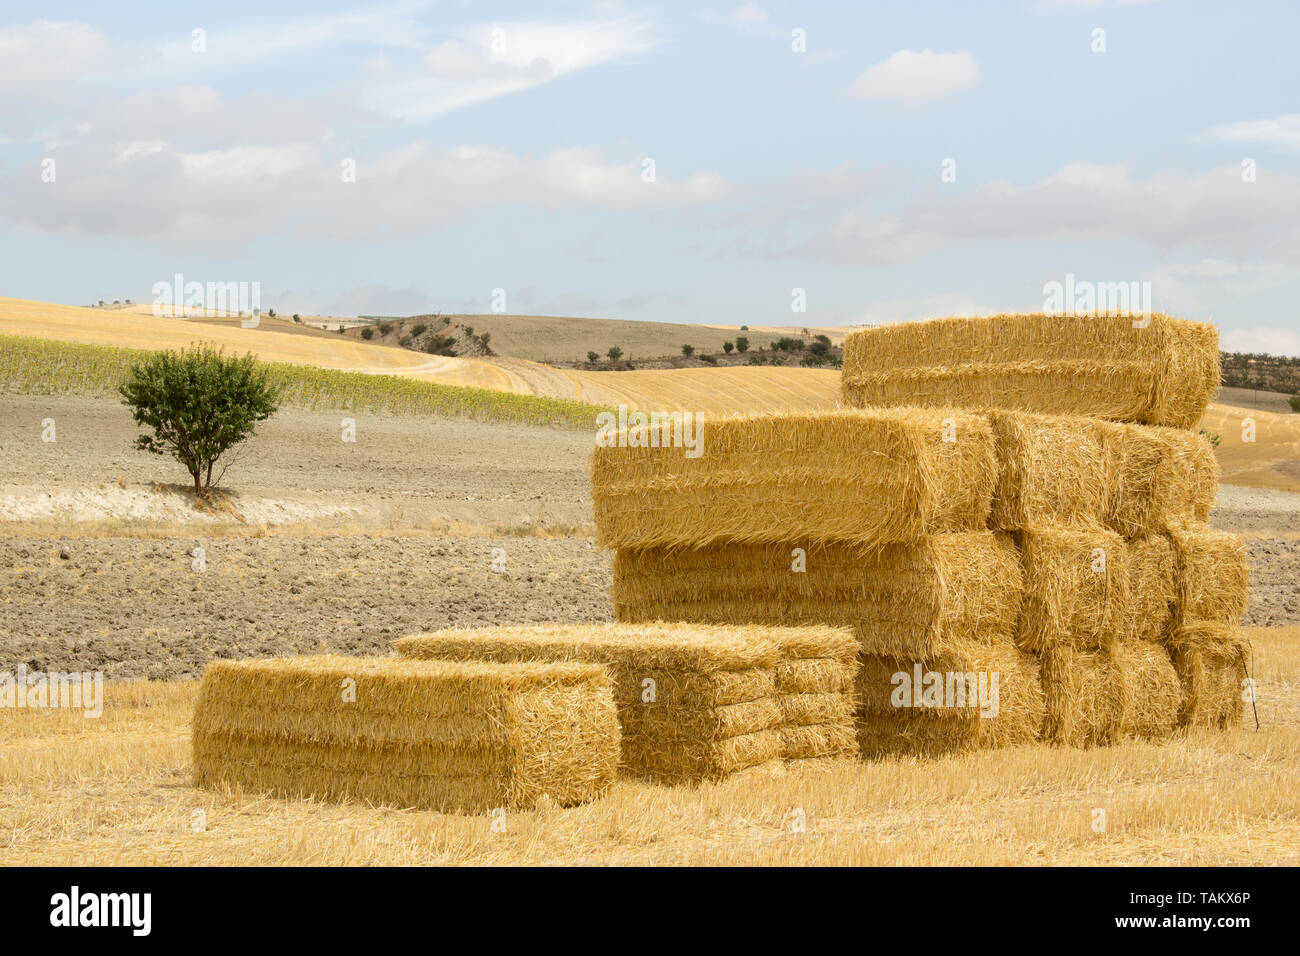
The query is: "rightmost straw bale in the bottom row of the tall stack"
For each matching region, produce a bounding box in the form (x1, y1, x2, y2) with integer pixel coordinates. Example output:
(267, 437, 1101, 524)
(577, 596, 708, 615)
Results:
(1170, 623, 1249, 728)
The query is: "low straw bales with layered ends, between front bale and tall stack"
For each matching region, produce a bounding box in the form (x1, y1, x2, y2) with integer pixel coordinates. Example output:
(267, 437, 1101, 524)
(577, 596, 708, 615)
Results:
(397, 623, 857, 783)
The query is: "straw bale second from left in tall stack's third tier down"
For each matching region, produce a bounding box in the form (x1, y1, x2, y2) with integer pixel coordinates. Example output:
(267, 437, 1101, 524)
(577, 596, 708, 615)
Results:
(1017, 527, 1128, 653)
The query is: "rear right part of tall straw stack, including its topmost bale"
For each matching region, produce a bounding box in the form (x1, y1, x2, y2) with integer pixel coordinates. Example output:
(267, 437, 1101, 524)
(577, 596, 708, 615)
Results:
(844, 315, 1248, 745)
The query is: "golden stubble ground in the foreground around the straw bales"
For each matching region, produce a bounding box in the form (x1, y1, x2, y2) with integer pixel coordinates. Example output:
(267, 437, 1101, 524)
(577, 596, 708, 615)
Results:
(0, 627, 1300, 865)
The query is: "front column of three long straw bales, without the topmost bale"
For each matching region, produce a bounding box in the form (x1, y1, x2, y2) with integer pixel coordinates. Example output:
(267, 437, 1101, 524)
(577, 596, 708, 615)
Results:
(592, 408, 1043, 750)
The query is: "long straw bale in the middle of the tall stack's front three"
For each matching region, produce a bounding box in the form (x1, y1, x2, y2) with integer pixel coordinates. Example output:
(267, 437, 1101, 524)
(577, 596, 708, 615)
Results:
(614, 531, 1022, 656)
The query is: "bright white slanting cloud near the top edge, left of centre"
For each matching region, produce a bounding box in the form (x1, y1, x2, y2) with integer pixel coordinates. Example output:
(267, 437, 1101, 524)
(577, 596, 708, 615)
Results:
(364, 17, 659, 121)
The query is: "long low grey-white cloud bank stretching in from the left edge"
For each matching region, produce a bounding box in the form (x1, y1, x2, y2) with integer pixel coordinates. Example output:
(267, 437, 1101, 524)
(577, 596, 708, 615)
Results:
(0, 140, 728, 248)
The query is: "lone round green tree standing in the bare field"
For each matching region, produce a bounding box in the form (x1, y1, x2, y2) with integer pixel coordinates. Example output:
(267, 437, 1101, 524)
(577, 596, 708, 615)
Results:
(118, 346, 281, 497)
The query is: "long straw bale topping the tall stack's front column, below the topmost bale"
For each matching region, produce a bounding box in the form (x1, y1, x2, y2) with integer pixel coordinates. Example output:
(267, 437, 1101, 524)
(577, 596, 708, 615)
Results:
(592, 408, 997, 548)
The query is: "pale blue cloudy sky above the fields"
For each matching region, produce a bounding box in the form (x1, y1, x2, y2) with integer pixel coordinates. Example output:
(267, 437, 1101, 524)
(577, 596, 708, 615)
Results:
(0, 0, 1300, 355)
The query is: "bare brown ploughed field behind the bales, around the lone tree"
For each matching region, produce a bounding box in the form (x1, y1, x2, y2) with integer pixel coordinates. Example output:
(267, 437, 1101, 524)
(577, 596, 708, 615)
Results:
(0, 395, 1300, 679)
